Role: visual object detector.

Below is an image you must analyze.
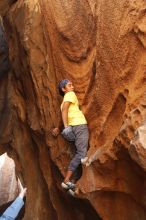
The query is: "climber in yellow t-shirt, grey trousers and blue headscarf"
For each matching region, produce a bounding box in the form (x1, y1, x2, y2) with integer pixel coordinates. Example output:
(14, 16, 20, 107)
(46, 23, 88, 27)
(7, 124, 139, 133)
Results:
(52, 79, 89, 192)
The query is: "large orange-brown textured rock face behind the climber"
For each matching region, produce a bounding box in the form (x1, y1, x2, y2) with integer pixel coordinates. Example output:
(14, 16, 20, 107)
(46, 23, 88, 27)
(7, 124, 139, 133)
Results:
(0, 0, 146, 220)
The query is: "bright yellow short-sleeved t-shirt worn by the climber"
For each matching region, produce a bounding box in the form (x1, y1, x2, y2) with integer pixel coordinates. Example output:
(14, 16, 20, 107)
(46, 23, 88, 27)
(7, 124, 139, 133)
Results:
(61, 92, 87, 126)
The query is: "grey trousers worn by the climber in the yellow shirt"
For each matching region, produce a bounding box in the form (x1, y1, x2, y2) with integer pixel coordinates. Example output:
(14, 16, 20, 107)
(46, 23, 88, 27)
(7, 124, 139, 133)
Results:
(68, 125, 89, 172)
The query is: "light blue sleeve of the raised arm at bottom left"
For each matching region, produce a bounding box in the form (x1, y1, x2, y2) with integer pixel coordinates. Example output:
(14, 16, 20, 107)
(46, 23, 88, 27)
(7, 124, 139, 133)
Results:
(2, 196, 24, 219)
